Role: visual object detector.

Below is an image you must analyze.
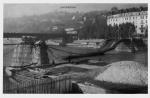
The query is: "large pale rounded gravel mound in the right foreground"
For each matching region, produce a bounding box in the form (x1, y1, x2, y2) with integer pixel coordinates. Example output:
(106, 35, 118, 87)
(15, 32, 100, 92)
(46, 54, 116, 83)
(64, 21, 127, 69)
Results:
(95, 61, 148, 86)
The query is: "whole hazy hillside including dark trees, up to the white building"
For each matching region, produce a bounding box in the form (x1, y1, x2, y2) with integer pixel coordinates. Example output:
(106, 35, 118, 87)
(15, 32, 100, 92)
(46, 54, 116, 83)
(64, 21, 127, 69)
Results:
(4, 11, 107, 39)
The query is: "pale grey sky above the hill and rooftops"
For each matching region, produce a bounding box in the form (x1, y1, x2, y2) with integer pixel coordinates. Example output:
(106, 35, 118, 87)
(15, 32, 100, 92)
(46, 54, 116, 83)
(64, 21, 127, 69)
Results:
(3, 3, 148, 18)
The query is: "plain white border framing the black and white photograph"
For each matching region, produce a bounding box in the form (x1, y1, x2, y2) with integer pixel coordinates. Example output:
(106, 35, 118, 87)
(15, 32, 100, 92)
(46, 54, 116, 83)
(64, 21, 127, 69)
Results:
(0, 0, 150, 98)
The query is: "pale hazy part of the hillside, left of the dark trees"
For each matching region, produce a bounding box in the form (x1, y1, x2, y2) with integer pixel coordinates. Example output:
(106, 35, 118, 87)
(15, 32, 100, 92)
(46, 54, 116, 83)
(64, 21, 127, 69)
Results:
(4, 12, 82, 33)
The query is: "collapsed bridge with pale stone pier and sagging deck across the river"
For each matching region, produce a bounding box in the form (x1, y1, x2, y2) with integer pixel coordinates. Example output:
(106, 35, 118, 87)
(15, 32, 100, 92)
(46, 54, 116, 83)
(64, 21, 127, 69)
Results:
(4, 35, 147, 66)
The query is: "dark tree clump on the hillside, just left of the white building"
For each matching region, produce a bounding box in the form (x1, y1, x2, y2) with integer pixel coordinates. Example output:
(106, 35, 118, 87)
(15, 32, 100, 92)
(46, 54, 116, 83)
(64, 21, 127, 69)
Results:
(79, 12, 107, 39)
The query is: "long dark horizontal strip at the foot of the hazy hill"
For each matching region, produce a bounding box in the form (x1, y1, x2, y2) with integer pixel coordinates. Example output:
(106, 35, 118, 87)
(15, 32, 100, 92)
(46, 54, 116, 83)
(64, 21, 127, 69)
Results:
(3, 30, 78, 44)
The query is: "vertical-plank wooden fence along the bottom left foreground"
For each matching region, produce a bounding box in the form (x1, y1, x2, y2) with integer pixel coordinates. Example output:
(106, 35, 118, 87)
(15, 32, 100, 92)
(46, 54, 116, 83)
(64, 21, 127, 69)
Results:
(3, 76, 72, 94)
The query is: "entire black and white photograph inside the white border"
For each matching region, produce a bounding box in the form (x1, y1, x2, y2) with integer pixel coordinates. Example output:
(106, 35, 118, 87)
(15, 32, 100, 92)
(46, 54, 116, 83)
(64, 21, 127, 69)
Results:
(1, 2, 148, 94)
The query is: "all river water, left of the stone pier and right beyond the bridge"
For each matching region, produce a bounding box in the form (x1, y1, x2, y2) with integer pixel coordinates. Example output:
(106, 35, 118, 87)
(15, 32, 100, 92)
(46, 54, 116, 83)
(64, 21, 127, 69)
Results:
(3, 40, 148, 66)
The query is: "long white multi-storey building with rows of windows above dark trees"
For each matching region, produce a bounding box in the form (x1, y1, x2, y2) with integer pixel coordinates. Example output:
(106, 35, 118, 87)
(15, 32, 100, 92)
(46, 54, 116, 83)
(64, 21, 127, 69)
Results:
(107, 11, 148, 34)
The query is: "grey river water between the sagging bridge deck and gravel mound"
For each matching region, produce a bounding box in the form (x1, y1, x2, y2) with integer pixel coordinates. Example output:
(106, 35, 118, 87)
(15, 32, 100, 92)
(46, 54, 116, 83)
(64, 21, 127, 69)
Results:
(100, 51, 148, 66)
